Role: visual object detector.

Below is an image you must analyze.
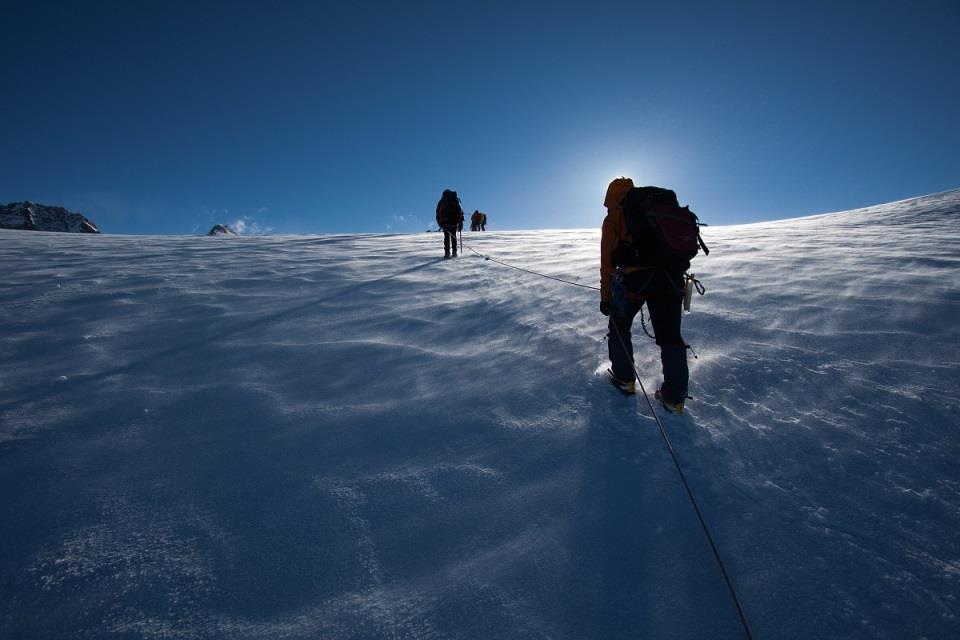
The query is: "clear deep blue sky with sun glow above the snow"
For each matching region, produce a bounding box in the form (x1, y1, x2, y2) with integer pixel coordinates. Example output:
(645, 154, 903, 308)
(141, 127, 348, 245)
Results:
(0, 0, 960, 234)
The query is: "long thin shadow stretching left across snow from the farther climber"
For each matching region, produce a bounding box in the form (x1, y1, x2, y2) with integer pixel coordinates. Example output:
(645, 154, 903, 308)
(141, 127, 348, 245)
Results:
(0, 258, 443, 412)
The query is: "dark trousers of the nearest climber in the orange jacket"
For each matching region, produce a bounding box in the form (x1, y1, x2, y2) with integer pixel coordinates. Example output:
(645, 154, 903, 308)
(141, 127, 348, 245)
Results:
(607, 291, 690, 403)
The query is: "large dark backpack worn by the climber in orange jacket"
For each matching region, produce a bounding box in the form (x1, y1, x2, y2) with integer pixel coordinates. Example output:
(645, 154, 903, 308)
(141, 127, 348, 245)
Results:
(613, 187, 710, 273)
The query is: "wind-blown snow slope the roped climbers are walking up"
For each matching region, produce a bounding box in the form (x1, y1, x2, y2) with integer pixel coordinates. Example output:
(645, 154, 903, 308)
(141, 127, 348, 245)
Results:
(0, 192, 960, 640)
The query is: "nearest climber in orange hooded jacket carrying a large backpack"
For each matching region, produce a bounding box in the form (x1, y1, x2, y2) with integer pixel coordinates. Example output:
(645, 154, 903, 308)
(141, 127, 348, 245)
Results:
(600, 178, 706, 414)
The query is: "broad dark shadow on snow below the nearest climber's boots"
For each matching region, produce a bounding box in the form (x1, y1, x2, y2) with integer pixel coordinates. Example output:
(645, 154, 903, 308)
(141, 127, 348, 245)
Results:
(558, 382, 742, 640)
